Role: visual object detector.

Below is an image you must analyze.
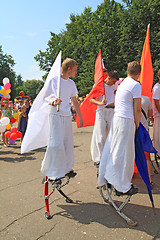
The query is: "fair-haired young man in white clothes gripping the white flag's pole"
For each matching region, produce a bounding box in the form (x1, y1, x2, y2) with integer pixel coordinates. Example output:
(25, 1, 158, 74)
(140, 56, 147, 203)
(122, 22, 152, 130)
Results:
(41, 58, 84, 182)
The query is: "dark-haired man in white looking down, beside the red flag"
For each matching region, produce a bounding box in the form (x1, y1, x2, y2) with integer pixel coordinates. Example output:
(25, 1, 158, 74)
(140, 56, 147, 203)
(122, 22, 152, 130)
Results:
(90, 71, 119, 164)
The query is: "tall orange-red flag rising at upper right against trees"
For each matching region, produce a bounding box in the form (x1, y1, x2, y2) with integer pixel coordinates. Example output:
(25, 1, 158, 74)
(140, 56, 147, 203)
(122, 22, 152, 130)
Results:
(139, 24, 154, 100)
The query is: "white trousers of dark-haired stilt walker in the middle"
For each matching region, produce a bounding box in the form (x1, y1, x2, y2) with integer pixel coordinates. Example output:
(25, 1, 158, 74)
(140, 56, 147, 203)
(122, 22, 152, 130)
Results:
(91, 108, 114, 162)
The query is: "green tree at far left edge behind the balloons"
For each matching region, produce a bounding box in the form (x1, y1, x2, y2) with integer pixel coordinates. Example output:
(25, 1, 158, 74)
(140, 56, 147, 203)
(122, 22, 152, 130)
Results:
(0, 46, 16, 99)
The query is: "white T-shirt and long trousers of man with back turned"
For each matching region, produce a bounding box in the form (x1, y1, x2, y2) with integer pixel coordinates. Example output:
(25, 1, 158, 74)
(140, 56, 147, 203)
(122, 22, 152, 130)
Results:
(98, 77, 141, 193)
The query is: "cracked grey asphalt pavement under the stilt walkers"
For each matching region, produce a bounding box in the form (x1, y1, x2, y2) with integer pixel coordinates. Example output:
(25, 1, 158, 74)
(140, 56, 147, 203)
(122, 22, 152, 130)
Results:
(0, 123, 160, 240)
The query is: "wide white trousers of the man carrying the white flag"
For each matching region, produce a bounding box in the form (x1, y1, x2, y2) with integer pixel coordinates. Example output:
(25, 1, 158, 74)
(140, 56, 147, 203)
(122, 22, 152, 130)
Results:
(41, 113, 74, 179)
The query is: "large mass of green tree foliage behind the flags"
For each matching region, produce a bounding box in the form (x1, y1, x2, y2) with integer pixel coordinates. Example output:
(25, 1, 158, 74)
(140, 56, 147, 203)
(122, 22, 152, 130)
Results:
(35, 0, 160, 95)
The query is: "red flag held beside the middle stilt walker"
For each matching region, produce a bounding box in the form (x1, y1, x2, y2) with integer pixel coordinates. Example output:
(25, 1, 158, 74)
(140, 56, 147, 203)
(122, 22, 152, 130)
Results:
(76, 50, 105, 127)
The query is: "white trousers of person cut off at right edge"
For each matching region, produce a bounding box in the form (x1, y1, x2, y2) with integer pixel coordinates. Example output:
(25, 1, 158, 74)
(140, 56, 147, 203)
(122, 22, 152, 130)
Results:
(153, 116, 160, 155)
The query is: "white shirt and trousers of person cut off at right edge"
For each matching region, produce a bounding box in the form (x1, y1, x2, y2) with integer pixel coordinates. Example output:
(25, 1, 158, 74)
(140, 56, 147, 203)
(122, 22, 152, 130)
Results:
(152, 83, 160, 155)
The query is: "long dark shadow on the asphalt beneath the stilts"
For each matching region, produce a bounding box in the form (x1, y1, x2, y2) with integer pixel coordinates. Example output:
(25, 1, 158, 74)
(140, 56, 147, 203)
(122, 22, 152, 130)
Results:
(56, 202, 160, 237)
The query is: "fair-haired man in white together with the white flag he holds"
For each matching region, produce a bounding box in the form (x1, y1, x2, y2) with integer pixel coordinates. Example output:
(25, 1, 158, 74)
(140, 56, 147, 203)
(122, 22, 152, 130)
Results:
(21, 52, 84, 180)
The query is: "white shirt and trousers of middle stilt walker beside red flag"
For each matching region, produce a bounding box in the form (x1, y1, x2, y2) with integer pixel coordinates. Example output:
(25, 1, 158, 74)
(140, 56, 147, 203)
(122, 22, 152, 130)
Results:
(91, 84, 115, 163)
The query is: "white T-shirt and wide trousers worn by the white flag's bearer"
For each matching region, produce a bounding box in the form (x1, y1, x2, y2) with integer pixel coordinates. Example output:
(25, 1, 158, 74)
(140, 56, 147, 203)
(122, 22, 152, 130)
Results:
(41, 78, 78, 179)
